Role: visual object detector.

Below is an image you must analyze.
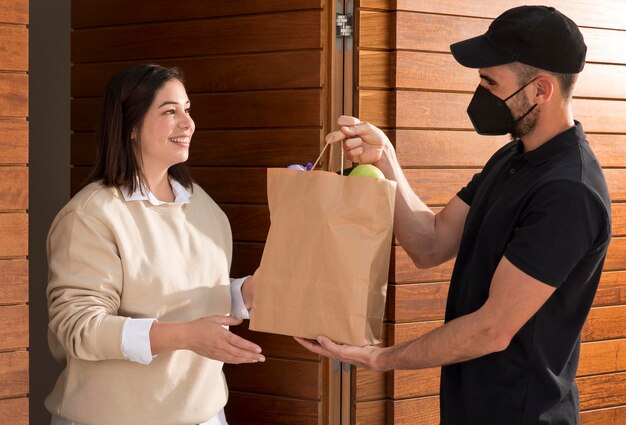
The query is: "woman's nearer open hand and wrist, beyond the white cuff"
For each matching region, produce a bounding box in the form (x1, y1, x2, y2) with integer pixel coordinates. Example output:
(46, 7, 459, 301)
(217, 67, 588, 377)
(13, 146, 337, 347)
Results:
(150, 316, 265, 364)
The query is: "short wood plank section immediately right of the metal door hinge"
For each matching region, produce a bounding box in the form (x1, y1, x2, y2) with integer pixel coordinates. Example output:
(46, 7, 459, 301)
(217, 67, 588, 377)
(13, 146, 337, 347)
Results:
(357, 10, 395, 49)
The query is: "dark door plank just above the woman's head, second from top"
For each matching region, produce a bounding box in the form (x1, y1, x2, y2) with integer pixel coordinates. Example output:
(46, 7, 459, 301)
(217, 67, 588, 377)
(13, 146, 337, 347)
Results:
(72, 11, 323, 63)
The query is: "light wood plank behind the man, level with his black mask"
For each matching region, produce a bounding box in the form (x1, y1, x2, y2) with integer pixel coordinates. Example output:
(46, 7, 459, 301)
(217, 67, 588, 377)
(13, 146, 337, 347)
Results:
(394, 90, 626, 133)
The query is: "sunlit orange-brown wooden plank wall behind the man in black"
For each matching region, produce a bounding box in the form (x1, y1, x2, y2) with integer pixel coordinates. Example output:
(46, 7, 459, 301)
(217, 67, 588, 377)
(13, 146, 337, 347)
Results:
(353, 0, 626, 425)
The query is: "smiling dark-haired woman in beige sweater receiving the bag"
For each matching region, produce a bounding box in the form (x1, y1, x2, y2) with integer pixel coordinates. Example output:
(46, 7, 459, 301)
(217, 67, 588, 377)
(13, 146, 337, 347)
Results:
(45, 65, 264, 425)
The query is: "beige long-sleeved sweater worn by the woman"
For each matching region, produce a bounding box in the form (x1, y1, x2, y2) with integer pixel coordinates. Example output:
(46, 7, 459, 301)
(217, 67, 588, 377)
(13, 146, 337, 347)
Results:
(45, 183, 232, 425)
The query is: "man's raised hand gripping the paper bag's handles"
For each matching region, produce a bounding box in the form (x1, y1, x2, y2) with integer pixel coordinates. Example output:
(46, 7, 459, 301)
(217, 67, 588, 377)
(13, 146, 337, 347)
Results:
(326, 115, 391, 164)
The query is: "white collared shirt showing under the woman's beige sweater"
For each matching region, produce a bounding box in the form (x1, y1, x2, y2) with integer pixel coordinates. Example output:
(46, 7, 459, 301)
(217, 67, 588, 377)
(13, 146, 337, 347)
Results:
(51, 179, 250, 425)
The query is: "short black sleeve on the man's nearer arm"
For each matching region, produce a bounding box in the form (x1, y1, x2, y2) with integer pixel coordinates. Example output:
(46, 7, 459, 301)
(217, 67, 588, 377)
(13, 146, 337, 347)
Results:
(504, 181, 610, 287)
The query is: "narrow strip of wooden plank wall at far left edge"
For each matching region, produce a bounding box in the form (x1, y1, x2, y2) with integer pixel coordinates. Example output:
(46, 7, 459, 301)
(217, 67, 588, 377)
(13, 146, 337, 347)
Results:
(0, 0, 28, 425)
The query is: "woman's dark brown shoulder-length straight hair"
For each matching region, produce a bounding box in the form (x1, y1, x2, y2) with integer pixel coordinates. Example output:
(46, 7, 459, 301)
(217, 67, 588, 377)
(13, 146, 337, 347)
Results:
(87, 64, 192, 192)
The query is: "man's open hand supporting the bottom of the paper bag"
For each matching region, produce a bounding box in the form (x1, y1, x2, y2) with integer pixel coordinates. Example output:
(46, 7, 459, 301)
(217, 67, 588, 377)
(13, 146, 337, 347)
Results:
(294, 336, 388, 370)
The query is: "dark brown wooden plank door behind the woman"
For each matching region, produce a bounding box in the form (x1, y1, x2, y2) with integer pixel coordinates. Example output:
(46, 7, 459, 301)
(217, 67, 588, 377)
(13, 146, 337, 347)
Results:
(71, 0, 329, 425)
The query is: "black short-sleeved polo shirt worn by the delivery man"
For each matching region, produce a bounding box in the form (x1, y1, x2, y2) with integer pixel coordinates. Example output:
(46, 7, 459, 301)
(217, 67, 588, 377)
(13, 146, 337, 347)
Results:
(441, 122, 611, 425)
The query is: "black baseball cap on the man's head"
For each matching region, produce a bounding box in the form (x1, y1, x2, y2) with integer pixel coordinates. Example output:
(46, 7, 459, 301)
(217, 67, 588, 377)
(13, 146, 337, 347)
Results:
(450, 6, 587, 74)
